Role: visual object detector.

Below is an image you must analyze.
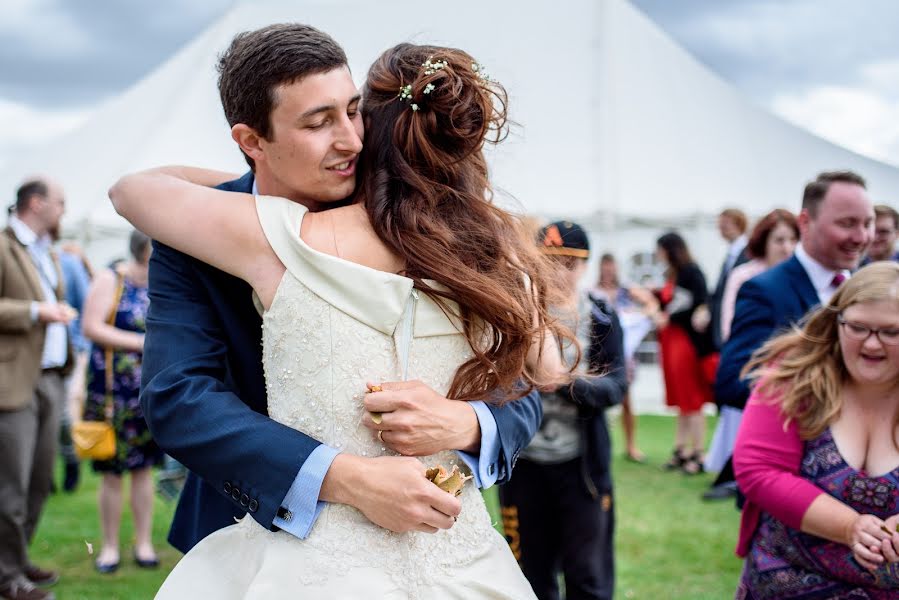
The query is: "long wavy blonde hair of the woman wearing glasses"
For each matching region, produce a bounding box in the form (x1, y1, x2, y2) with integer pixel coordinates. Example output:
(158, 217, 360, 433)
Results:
(742, 261, 899, 440)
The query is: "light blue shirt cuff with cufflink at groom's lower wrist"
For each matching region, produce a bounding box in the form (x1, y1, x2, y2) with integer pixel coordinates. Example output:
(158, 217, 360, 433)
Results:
(272, 444, 339, 539)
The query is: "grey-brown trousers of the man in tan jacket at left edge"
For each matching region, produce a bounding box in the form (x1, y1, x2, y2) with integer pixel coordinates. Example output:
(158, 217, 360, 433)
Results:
(0, 371, 65, 587)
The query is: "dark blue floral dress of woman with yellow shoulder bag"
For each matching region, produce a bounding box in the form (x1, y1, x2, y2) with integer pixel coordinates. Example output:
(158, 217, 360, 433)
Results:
(84, 277, 162, 474)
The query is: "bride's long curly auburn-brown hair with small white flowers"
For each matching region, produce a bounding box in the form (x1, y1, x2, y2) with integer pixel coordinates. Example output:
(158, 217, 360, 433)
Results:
(357, 44, 571, 403)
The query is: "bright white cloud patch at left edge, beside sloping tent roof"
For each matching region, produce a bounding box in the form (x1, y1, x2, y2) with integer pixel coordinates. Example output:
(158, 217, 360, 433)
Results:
(0, 98, 94, 167)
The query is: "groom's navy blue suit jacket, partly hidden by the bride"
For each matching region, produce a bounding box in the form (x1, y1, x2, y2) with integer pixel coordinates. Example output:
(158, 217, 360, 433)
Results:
(141, 173, 543, 552)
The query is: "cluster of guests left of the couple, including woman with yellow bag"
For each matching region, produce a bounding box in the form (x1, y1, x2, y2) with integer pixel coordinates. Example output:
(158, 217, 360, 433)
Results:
(0, 179, 162, 600)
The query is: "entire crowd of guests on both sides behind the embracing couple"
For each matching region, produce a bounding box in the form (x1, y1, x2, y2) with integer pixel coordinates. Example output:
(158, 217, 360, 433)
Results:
(0, 172, 899, 600)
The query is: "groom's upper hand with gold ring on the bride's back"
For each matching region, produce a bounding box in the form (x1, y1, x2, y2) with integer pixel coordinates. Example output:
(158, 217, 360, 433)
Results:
(362, 381, 481, 456)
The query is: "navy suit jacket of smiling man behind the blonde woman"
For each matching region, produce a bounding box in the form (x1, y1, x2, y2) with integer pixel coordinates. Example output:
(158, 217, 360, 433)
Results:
(715, 255, 819, 410)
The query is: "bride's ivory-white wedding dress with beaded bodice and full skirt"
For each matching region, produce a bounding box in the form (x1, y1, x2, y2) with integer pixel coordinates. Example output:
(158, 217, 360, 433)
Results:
(157, 197, 535, 600)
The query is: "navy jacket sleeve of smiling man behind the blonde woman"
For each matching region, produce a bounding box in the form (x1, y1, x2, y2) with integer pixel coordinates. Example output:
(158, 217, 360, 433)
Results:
(715, 279, 777, 409)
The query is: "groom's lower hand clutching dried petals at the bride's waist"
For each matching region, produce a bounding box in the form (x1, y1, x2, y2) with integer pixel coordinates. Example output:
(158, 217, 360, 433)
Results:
(319, 454, 462, 533)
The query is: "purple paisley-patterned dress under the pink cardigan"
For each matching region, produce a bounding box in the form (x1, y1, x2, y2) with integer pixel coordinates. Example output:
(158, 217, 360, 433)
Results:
(736, 428, 899, 600)
